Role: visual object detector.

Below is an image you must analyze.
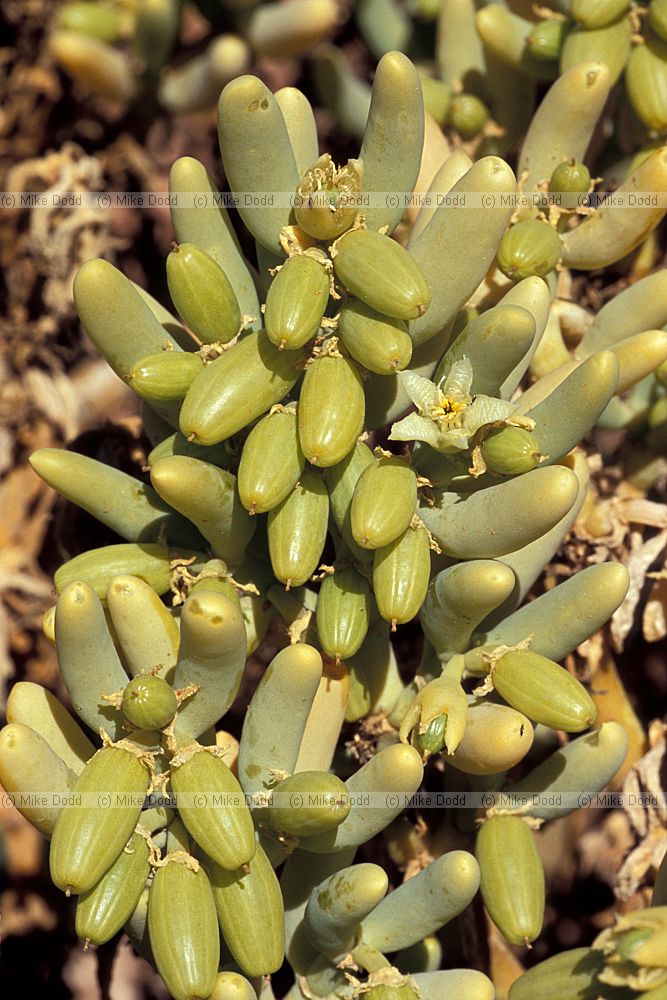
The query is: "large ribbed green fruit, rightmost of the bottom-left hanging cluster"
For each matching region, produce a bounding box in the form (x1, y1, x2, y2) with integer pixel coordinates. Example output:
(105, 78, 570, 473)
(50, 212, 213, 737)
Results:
(210, 846, 285, 976)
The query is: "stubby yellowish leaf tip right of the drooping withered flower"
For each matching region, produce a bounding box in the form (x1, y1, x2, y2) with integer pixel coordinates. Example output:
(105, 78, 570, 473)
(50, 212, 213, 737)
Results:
(447, 701, 534, 774)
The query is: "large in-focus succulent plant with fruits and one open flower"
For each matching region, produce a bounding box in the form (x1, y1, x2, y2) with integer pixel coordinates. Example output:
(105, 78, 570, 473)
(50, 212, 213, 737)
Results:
(5, 47, 667, 1000)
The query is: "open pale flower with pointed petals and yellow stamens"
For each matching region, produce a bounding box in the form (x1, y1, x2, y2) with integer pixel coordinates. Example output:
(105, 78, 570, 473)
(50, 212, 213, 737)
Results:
(389, 358, 516, 455)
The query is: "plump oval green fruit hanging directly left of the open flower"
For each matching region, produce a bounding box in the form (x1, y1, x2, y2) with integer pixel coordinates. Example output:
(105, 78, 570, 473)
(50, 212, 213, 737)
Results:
(298, 354, 365, 467)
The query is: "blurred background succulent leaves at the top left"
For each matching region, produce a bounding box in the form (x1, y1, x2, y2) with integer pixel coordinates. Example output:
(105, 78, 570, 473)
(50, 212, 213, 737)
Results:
(49, 0, 338, 114)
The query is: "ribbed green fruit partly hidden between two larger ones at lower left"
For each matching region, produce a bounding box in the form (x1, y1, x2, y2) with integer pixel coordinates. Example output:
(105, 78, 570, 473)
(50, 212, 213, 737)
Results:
(75, 833, 150, 945)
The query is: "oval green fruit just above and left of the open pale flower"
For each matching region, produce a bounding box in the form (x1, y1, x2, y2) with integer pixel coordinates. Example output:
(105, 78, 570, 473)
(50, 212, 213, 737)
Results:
(338, 300, 412, 375)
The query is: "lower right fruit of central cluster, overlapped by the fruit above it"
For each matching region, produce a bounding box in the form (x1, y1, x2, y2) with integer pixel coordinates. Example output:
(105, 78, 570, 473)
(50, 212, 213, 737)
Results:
(373, 522, 431, 630)
